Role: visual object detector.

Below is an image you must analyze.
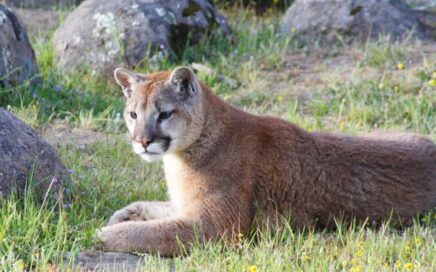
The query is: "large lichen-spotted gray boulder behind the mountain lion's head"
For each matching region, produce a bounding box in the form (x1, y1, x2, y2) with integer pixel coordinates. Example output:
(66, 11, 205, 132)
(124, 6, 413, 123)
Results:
(54, 0, 230, 74)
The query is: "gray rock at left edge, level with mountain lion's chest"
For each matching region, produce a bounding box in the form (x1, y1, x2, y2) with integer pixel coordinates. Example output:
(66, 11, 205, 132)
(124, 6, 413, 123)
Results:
(0, 108, 68, 200)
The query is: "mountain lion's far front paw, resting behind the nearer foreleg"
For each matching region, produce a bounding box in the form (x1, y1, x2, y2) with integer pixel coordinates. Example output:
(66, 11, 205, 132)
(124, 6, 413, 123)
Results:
(106, 201, 174, 226)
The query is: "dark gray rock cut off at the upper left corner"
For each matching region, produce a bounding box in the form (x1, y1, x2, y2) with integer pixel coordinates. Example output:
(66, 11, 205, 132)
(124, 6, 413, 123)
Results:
(0, 4, 38, 87)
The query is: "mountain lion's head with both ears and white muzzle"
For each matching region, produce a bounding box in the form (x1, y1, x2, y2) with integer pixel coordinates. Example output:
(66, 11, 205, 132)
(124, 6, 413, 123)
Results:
(114, 67, 204, 162)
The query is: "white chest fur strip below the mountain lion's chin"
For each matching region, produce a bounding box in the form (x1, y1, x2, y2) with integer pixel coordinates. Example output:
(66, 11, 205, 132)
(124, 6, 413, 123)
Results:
(163, 154, 186, 211)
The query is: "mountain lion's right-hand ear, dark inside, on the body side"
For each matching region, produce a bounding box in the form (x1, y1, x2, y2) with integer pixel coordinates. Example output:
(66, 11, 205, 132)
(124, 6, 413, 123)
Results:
(169, 66, 197, 99)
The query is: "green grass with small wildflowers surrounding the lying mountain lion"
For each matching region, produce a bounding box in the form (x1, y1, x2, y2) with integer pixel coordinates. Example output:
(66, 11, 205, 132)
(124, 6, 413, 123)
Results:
(0, 6, 436, 271)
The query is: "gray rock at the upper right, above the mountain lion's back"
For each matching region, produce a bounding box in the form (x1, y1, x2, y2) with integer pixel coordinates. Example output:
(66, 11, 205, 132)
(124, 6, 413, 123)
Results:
(280, 0, 430, 39)
